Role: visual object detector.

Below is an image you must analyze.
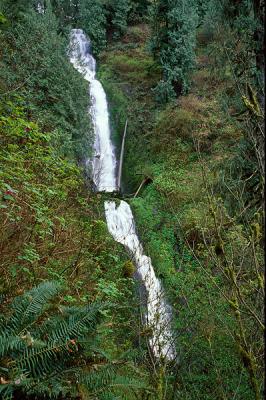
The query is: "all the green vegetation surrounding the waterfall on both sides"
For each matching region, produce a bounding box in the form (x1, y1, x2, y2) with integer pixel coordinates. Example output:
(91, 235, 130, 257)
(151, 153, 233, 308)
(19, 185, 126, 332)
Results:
(0, 0, 265, 400)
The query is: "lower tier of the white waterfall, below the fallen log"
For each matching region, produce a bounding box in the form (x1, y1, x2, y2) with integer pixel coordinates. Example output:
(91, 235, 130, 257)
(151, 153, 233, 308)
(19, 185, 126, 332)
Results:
(104, 201, 175, 359)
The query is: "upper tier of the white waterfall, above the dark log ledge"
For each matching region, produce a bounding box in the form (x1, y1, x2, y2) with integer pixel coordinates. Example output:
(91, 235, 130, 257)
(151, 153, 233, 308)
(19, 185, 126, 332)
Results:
(70, 29, 117, 192)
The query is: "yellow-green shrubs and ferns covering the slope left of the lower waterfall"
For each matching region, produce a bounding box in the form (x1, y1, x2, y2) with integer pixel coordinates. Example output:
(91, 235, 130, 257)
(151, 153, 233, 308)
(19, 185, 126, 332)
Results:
(0, 97, 150, 399)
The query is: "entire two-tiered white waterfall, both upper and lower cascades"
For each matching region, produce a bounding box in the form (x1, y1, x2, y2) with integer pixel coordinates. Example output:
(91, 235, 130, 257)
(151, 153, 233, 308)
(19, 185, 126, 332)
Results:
(70, 29, 176, 361)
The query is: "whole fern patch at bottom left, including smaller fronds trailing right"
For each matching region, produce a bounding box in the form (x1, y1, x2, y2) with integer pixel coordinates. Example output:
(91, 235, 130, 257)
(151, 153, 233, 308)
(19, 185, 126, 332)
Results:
(0, 282, 150, 400)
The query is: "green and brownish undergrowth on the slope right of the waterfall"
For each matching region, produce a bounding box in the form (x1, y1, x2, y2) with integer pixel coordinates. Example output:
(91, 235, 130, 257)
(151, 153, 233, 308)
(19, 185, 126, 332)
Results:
(99, 22, 263, 400)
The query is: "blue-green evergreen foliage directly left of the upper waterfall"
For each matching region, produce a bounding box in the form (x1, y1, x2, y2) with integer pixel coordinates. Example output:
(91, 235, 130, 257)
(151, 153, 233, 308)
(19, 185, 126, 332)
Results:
(0, 2, 90, 159)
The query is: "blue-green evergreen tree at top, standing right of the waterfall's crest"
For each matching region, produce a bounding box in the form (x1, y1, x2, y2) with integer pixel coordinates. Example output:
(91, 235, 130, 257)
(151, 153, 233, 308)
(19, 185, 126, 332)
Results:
(151, 0, 198, 101)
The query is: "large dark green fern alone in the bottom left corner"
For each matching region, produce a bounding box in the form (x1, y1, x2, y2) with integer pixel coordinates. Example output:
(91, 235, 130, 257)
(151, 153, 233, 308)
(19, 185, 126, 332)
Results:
(0, 282, 100, 399)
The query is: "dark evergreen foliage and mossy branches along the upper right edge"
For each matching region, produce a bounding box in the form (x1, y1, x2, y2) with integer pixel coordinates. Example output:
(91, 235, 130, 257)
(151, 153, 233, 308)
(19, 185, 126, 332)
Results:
(204, 1, 265, 213)
